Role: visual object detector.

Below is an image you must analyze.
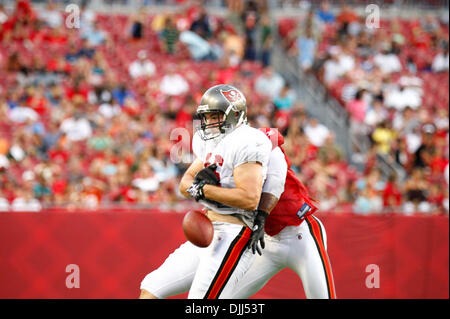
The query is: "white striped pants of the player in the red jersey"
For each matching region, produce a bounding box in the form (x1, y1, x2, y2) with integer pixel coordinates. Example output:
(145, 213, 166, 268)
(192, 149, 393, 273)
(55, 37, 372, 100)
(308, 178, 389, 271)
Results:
(233, 215, 336, 299)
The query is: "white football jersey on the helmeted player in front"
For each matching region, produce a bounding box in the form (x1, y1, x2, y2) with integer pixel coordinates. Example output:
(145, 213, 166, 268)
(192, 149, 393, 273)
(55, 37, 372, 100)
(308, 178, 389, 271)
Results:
(192, 124, 272, 227)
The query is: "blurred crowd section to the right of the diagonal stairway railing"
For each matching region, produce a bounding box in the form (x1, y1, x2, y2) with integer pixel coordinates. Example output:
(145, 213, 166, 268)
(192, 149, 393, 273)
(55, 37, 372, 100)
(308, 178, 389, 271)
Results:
(280, 1, 449, 214)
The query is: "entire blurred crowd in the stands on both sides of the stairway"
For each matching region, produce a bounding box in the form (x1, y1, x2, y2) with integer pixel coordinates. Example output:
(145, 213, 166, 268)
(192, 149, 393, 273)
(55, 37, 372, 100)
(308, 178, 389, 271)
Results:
(0, 0, 448, 214)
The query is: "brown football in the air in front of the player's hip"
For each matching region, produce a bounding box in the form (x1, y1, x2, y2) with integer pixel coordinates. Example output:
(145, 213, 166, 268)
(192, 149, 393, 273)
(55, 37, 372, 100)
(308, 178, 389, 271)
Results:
(183, 210, 214, 247)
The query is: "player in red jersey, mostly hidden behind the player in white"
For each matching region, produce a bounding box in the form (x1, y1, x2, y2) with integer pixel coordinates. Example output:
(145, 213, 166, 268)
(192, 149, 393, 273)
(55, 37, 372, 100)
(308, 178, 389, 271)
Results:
(233, 128, 336, 299)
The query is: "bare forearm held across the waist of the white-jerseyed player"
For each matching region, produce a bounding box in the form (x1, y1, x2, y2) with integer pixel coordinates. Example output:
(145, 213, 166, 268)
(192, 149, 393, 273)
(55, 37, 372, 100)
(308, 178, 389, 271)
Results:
(203, 185, 261, 210)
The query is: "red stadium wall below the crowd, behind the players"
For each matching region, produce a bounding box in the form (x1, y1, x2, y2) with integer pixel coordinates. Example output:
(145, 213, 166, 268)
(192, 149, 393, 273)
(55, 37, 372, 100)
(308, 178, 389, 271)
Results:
(0, 211, 449, 299)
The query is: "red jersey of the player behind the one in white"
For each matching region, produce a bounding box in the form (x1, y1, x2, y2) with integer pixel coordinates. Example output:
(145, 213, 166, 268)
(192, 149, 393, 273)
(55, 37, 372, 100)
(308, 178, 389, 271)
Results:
(260, 128, 317, 236)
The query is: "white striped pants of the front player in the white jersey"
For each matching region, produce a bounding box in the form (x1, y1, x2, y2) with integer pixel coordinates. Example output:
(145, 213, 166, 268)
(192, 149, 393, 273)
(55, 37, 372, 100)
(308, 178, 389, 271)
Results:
(141, 222, 255, 299)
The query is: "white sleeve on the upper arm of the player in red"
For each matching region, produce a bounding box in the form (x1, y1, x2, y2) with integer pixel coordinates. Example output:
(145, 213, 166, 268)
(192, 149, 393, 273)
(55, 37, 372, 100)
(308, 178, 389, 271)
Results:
(262, 147, 287, 199)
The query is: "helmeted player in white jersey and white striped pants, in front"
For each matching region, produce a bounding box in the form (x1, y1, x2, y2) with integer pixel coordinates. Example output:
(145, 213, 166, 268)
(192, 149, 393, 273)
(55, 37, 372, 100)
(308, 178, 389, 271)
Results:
(140, 85, 272, 299)
